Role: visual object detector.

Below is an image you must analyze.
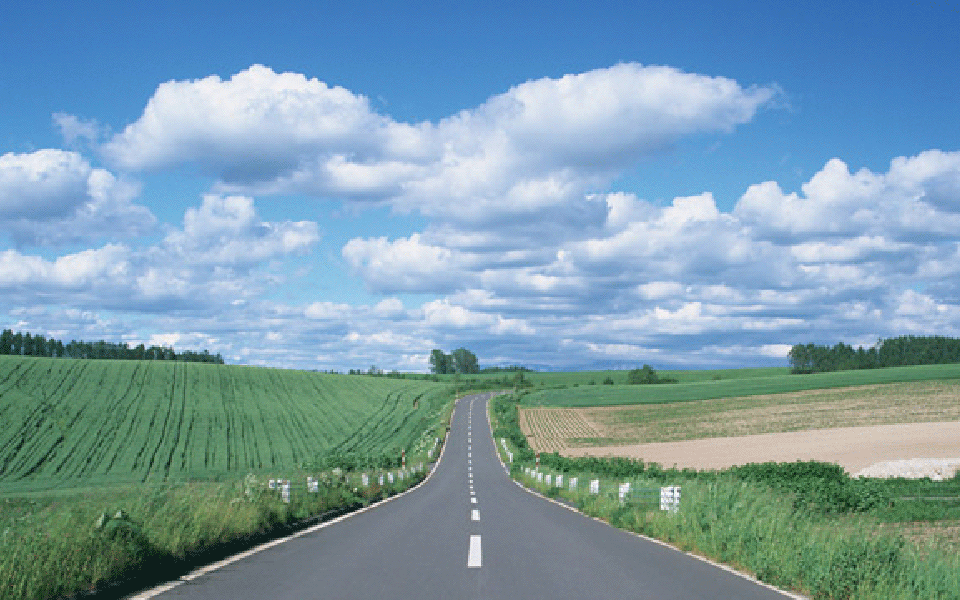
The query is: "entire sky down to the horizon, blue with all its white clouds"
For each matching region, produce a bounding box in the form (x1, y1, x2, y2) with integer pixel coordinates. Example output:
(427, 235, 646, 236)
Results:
(0, 1, 960, 371)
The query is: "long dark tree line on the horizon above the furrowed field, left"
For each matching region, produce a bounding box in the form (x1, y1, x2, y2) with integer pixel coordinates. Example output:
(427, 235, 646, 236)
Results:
(0, 329, 224, 365)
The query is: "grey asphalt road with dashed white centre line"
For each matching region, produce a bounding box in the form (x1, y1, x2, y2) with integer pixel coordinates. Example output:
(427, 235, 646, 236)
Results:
(141, 394, 787, 600)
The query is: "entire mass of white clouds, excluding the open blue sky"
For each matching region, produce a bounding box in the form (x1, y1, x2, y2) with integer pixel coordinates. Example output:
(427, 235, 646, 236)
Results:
(7, 64, 960, 370)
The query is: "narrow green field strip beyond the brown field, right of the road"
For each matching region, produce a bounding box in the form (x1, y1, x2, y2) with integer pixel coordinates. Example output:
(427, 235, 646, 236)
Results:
(521, 364, 960, 407)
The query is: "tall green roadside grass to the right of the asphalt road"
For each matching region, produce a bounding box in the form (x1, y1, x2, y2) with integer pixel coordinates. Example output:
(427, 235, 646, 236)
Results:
(513, 468, 960, 600)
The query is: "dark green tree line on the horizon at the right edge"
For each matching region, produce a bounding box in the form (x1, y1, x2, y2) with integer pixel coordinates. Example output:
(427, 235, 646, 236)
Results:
(788, 335, 960, 373)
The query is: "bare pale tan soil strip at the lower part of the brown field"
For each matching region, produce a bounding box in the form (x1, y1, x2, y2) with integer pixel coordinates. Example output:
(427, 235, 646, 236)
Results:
(563, 421, 960, 473)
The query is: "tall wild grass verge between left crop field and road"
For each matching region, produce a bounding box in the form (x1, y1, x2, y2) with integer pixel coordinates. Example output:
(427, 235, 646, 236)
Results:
(0, 473, 423, 600)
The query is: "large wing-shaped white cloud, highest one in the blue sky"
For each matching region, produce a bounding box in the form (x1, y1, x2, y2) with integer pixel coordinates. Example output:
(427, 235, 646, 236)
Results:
(102, 63, 778, 230)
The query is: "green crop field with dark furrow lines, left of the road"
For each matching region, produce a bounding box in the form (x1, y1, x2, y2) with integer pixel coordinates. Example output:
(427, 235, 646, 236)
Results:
(0, 356, 450, 494)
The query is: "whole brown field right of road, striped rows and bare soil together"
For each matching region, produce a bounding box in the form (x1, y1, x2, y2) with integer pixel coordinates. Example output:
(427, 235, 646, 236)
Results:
(520, 381, 960, 472)
